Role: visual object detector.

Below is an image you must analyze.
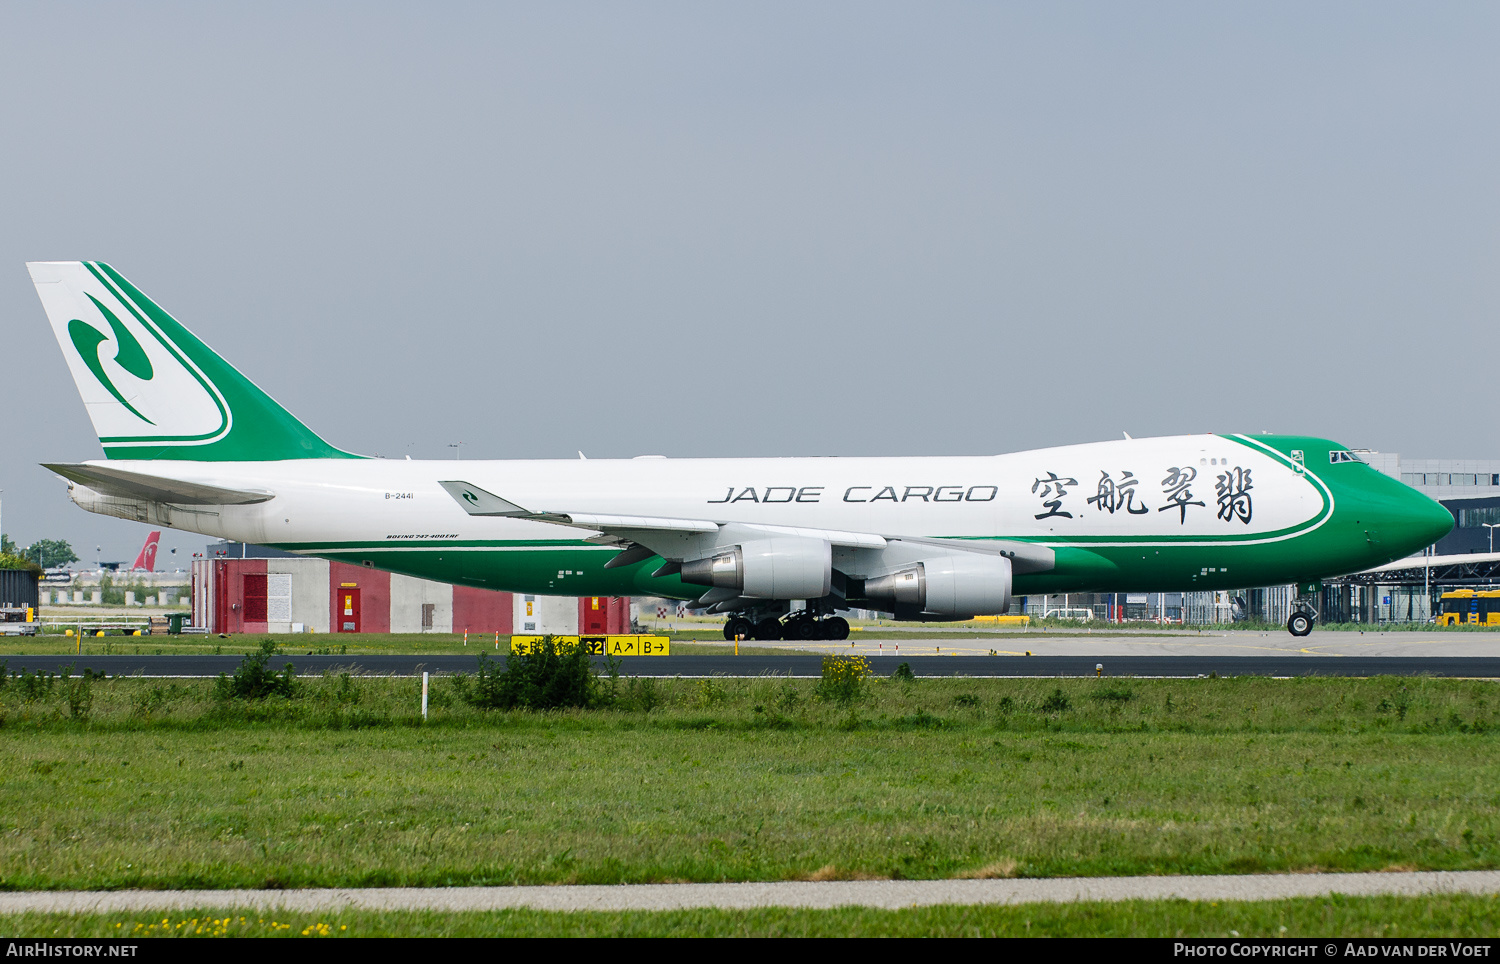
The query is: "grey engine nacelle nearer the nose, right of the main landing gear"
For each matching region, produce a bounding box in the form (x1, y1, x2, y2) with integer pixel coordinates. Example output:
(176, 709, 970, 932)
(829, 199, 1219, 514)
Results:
(864, 552, 1011, 618)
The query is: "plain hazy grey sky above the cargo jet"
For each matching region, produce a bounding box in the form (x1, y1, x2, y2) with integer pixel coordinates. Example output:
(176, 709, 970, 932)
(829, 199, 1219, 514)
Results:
(0, 3, 1500, 561)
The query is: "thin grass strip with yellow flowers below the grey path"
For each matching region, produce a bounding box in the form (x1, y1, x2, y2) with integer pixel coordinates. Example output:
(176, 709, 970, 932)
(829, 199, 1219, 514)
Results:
(0, 895, 1500, 939)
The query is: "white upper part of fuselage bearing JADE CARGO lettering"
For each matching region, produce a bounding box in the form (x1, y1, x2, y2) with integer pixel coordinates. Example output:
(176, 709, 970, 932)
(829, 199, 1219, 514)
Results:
(96, 435, 1328, 546)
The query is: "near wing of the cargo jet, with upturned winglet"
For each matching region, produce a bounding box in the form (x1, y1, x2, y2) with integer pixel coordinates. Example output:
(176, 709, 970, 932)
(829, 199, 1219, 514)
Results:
(438, 481, 1055, 573)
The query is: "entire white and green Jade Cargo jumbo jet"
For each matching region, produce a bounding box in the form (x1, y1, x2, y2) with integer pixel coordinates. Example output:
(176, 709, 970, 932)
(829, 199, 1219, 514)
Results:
(29, 261, 1452, 639)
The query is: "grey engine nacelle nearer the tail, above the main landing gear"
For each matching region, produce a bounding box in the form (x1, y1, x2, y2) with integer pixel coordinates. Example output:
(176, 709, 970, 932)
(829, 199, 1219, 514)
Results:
(680, 537, 834, 600)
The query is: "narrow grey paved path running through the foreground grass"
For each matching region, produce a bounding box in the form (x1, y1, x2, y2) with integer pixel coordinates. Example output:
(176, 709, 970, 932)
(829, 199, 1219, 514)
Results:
(0, 871, 1500, 915)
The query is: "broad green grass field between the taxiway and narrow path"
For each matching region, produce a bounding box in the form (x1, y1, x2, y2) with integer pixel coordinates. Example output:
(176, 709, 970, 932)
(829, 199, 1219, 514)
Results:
(0, 662, 1500, 889)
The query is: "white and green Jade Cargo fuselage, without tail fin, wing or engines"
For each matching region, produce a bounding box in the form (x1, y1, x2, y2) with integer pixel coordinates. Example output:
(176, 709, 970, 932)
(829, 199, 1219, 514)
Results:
(75, 435, 1452, 600)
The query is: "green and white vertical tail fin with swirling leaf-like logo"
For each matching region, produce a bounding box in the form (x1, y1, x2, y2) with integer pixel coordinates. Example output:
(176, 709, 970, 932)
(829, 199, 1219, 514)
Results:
(26, 261, 359, 462)
